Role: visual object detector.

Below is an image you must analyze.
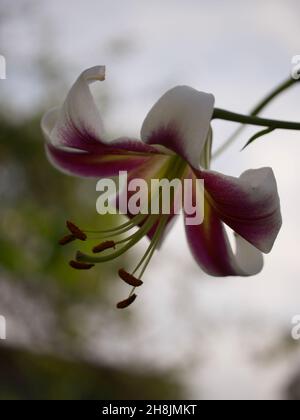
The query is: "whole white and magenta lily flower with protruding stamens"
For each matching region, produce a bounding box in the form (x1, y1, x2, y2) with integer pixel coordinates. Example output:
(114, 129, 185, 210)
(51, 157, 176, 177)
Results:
(41, 66, 282, 308)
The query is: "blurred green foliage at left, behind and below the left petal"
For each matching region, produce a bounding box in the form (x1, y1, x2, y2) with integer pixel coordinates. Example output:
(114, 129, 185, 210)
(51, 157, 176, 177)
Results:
(0, 116, 124, 306)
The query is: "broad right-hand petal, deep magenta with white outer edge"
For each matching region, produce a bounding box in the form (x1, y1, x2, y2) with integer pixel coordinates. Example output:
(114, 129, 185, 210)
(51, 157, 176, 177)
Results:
(198, 168, 282, 253)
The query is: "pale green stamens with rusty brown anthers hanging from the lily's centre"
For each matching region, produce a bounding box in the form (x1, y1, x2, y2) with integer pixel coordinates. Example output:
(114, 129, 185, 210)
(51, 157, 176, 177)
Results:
(59, 156, 187, 309)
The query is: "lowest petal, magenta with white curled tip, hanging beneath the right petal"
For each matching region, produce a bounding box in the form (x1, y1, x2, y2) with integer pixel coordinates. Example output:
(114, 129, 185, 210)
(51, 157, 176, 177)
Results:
(185, 173, 263, 277)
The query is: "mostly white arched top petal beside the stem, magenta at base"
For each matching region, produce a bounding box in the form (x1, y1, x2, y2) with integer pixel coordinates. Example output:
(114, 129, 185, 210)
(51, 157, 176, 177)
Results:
(141, 86, 214, 168)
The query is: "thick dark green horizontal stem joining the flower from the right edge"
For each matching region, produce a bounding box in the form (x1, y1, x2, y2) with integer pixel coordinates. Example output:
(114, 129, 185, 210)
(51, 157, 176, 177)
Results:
(212, 108, 300, 130)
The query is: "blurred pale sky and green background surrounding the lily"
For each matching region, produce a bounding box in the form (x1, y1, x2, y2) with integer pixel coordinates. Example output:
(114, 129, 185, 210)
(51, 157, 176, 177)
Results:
(0, 0, 300, 399)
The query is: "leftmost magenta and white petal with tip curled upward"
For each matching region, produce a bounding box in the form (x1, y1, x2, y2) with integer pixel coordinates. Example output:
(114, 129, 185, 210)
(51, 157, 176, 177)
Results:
(41, 66, 166, 177)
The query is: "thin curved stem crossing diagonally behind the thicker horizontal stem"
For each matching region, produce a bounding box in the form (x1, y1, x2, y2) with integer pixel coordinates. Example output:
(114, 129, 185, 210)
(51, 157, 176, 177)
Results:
(212, 78, 299, 159)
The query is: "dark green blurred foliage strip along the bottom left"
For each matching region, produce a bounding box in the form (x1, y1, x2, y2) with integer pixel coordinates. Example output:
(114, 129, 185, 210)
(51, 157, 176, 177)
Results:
(0, 348, 178, 400)
